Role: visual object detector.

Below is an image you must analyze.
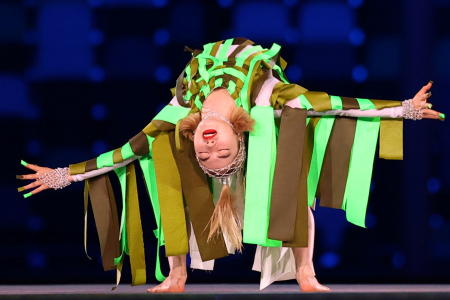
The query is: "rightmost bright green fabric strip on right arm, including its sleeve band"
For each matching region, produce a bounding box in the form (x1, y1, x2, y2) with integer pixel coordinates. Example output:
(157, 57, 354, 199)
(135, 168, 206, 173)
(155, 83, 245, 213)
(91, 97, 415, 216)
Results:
(342, 99, 380, 227)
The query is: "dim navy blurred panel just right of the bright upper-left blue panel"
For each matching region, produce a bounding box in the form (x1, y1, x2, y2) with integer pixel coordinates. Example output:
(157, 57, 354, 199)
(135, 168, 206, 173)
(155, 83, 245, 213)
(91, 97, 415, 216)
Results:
(105, 36, 158, 79)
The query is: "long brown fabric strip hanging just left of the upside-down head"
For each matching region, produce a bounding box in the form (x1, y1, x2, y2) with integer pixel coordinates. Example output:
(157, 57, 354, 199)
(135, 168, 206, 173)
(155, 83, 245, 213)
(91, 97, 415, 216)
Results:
(169, 132, 228, 261)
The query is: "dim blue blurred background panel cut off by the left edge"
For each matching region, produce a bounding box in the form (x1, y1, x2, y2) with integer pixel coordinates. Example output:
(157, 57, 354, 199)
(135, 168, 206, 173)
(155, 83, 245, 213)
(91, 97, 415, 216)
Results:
(0, 73, 40, 119)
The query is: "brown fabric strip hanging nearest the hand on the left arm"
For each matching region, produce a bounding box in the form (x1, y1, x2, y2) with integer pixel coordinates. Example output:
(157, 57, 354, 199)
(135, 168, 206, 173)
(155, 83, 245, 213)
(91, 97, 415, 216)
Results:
(87, 174, 120, 271)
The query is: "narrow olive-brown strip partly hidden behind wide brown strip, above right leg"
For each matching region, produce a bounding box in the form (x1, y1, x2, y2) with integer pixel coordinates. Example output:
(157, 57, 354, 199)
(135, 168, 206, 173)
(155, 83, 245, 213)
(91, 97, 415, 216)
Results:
(283, 117, 320, 247)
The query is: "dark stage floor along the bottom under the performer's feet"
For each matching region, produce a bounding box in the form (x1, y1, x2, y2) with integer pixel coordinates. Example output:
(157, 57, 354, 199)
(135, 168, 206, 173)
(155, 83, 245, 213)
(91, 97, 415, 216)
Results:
(0, 284, 450, 299)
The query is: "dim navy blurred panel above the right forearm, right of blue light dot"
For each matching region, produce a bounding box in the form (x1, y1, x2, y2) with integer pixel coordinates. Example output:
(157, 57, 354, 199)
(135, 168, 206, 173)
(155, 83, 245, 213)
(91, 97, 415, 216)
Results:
(366, 36, 402, 80)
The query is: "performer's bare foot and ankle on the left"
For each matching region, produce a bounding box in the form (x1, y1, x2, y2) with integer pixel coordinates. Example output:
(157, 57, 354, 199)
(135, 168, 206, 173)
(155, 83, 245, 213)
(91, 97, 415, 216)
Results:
(147, 255, 187, 293)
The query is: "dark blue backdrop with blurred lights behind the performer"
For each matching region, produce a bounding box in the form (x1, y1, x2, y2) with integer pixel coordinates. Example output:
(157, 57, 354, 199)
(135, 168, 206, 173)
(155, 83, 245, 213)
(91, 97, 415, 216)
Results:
(0, 0, 450, 283)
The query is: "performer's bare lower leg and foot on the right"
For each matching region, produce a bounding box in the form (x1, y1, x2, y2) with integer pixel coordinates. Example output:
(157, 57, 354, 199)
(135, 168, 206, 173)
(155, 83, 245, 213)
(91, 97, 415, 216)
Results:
(292, 208, 330, 292)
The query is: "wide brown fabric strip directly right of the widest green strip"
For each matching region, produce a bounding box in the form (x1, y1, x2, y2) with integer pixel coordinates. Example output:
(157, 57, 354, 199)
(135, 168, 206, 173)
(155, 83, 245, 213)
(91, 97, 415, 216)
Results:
(268, 106, 306, 241)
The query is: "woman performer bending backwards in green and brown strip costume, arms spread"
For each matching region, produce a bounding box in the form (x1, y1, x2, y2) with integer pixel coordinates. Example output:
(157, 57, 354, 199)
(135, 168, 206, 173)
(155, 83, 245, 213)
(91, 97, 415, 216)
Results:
(18, 38, 445, 292)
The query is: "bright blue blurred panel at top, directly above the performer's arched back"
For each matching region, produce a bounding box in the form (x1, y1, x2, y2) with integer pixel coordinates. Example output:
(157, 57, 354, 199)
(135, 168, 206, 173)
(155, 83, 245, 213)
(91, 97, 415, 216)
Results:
(232, 2, 288, 42)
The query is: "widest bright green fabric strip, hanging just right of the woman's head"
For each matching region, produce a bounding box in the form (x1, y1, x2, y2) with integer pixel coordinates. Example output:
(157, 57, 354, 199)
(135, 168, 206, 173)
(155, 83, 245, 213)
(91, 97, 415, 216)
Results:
(243, 106, 281, 247)
